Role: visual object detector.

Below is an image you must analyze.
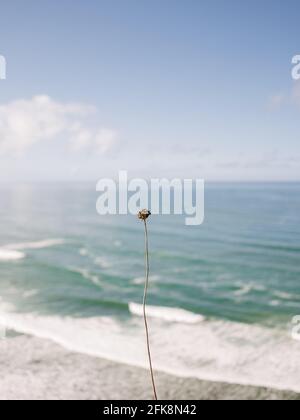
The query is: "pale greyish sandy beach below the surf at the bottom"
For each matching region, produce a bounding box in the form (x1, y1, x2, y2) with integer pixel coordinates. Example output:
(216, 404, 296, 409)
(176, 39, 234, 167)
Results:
(0, 335, 300, 400)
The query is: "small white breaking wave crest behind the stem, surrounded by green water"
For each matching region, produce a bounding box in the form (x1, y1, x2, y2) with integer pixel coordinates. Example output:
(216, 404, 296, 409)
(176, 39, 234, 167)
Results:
(128, 302, 205, 324)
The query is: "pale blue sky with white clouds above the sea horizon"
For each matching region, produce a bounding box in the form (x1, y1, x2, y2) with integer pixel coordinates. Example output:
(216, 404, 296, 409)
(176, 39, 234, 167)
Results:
(0, 0, 300, 183)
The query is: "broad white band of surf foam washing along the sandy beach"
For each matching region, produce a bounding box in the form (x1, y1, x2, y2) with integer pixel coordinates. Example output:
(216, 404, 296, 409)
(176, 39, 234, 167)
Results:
(0, 312, 300, 392)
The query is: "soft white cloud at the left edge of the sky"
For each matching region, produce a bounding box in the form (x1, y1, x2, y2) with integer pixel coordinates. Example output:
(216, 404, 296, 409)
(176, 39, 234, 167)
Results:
(0, 96, 117, 154)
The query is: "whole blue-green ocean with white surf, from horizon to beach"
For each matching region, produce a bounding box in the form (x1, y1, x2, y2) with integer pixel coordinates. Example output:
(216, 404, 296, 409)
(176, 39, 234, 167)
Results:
(0, 183, 300, 392)
